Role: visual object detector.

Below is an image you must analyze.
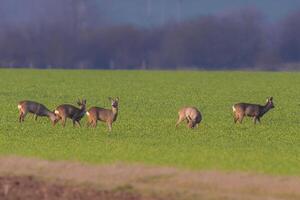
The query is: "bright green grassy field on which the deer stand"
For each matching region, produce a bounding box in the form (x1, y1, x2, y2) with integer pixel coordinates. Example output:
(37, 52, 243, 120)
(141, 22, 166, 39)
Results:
(0, 69, 300, 175)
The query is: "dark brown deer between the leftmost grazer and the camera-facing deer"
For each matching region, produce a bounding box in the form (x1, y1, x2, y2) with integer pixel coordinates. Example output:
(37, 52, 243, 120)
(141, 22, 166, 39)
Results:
(54, 100, 86, 127)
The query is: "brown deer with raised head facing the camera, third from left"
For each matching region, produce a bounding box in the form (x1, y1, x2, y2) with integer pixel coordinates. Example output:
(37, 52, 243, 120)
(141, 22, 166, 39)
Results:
(86, 97, 119, 131)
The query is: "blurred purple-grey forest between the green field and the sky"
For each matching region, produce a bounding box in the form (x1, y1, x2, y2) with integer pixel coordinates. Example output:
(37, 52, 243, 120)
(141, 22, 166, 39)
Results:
(0, 0, 300, 70)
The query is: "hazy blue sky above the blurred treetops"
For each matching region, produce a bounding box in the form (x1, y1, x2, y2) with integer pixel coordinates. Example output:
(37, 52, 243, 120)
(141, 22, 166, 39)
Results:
(0, 0, 300, 27)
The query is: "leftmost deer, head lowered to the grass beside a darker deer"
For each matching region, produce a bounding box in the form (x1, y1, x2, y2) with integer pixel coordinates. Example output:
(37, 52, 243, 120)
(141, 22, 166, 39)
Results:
(18, 101, 56, 125)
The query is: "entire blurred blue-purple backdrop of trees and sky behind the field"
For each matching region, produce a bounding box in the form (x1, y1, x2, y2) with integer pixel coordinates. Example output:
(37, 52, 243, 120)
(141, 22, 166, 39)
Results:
(0, 0, 300, 70)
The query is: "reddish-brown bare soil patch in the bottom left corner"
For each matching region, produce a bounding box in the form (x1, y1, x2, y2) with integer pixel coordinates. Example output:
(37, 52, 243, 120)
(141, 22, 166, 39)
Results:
(0, 176, 140, 200)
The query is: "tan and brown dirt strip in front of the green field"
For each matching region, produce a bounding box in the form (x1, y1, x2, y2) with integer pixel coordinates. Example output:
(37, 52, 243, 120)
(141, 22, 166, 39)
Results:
(0, 157, 300, 200)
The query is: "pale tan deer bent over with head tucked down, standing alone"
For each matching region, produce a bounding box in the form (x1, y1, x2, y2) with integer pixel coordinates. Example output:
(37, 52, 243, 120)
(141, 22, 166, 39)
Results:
(175, 107, 202, 128)
